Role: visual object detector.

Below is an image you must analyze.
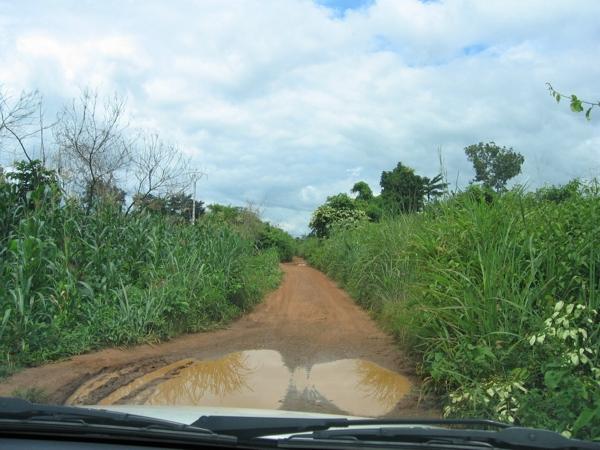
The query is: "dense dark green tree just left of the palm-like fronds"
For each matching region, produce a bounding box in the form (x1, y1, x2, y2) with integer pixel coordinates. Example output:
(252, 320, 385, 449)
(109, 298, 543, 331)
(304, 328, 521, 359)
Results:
(380, 162, 425, 213)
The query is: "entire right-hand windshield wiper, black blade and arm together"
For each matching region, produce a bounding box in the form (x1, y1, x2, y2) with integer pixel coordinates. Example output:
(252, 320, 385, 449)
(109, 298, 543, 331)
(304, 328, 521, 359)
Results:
(192, 416, 600, 450)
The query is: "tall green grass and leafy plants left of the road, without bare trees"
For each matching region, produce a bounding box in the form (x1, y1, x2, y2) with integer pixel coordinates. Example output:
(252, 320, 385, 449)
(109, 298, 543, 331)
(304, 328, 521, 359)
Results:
(0, 163, 280, 374)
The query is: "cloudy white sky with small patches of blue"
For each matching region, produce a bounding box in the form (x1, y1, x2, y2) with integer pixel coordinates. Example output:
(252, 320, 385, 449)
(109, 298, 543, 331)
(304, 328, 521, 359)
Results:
(0, 0, 600, 235)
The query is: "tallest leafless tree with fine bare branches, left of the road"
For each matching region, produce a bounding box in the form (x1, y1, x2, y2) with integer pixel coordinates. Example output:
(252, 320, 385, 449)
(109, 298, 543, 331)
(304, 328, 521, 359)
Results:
(55, 89, 131, 208)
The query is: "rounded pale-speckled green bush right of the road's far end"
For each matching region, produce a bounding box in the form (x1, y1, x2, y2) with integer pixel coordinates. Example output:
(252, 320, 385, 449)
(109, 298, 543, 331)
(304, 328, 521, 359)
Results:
(309, 194, 367, 237)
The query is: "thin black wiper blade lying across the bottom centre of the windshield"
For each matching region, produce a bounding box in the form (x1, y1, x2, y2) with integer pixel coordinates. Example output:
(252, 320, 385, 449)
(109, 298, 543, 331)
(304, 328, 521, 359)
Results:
(192, 415, 510, 439)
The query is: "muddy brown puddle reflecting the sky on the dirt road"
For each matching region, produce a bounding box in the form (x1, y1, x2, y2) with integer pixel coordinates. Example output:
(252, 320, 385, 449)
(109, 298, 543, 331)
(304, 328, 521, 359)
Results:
(67, 350, 412, 416)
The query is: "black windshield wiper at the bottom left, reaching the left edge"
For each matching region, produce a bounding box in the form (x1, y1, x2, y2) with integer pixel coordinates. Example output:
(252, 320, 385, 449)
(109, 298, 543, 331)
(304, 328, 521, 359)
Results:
(0, 397, 236, 441)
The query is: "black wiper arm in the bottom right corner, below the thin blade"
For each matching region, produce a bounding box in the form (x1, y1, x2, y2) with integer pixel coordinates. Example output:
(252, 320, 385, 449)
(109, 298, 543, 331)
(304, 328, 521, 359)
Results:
(300, 427, 600, 450)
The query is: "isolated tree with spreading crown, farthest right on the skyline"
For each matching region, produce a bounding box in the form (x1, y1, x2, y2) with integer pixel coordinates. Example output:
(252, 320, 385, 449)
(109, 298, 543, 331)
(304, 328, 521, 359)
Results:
(465, 142, 525, 192)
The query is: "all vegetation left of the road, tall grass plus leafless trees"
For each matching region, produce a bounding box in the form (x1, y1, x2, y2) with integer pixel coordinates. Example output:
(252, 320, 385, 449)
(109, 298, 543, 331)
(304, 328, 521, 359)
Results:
(0, 88, 295, 377)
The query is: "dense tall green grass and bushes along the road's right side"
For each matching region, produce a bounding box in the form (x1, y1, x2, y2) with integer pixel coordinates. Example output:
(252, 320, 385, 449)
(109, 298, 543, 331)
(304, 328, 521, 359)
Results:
(303, 184, 600, 438)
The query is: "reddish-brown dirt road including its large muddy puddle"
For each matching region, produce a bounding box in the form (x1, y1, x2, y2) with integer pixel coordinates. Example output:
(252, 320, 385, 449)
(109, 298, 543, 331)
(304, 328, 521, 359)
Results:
(0, 260, 437, 416)
